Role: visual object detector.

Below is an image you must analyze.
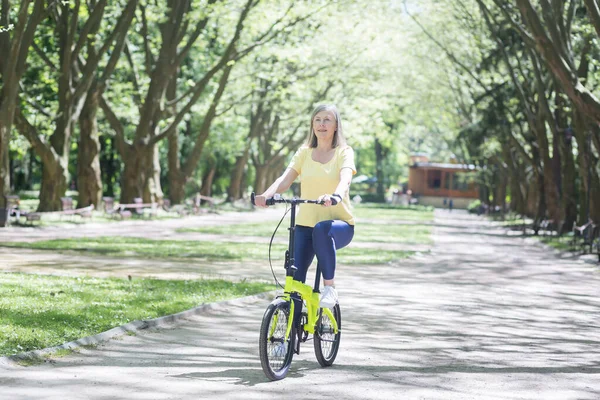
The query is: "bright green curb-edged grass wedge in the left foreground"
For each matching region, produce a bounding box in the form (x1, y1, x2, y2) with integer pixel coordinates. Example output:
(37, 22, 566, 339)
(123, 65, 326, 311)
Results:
(0, 273, 274, 356)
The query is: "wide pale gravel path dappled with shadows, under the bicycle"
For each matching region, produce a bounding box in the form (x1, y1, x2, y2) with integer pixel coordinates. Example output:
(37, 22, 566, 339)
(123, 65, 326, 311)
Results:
(0, 210, 600, 400)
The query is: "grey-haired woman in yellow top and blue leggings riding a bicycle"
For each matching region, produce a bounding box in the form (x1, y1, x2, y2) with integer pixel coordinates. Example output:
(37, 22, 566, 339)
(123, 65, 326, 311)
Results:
(255, 105, 356, 308)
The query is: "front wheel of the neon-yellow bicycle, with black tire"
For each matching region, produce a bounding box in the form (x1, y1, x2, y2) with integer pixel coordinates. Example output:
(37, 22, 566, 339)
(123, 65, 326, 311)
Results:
(258, 299, 295, 381)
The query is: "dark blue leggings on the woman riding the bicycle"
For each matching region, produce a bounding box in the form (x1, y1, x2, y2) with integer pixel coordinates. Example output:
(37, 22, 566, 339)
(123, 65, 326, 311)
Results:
(294, 220, 354, 282)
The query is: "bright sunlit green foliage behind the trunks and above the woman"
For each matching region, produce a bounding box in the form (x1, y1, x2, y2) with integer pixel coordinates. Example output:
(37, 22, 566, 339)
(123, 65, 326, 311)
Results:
(4, 0, 492, 206)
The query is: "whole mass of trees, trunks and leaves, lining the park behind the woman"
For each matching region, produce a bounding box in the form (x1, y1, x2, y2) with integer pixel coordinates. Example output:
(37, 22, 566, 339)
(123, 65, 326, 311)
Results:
(0, 0, 600, 226)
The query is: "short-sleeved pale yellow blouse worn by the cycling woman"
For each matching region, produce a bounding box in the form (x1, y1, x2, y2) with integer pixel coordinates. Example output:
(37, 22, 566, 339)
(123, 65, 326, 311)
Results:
(288, 146, 356, 227)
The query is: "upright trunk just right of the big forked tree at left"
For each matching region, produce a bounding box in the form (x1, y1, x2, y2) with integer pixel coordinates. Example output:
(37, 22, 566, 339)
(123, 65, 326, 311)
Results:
(77, 86, 102, 208)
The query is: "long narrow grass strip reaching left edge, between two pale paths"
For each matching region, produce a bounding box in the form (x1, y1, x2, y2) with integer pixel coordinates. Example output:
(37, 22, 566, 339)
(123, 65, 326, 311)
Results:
(2, 236, 414, 264)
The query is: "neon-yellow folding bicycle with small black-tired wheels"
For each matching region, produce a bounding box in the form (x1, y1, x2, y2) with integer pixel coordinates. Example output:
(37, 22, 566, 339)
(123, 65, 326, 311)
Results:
(251, 193, 342, 381)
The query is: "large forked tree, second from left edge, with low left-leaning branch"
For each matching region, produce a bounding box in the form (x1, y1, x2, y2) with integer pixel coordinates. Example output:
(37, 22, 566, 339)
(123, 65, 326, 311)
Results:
(16, 0, 136, 211)
